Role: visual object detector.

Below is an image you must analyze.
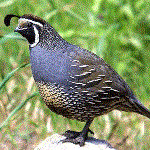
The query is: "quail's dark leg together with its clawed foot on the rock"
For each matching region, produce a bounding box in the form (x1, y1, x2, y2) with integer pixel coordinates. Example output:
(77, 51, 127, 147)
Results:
(62, 120, 94, 146)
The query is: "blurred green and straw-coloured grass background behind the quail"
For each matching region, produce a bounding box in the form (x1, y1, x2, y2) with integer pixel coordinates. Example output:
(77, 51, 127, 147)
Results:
(0, 0, 150, 150)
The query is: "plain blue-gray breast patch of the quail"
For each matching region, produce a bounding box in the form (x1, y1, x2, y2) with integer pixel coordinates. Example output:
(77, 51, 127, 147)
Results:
(30, 46, 71, 83)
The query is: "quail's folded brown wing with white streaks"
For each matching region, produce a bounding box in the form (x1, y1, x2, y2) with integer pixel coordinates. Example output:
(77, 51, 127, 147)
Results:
(68, 49, 132, 98)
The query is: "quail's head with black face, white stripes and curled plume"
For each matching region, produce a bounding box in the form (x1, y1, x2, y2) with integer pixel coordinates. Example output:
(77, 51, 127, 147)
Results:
(4, 14, 46, 47)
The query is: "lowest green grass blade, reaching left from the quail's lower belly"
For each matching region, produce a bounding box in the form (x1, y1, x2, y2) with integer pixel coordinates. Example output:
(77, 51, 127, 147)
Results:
(0, 92, 39, 130)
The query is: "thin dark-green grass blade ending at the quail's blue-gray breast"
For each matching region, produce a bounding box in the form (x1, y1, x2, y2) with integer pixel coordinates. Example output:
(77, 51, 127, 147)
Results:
(0, 63, 29, 90)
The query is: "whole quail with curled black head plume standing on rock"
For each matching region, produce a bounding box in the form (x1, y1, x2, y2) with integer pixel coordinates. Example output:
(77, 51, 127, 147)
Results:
(4, 14, 150, 146)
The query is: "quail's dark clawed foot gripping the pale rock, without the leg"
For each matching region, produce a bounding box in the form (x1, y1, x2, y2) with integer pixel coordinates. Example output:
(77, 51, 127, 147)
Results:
(61, 129, 94, 146)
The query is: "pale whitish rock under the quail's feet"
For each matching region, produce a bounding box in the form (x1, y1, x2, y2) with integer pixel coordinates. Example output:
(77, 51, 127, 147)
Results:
(35, 134, 115, 150)
